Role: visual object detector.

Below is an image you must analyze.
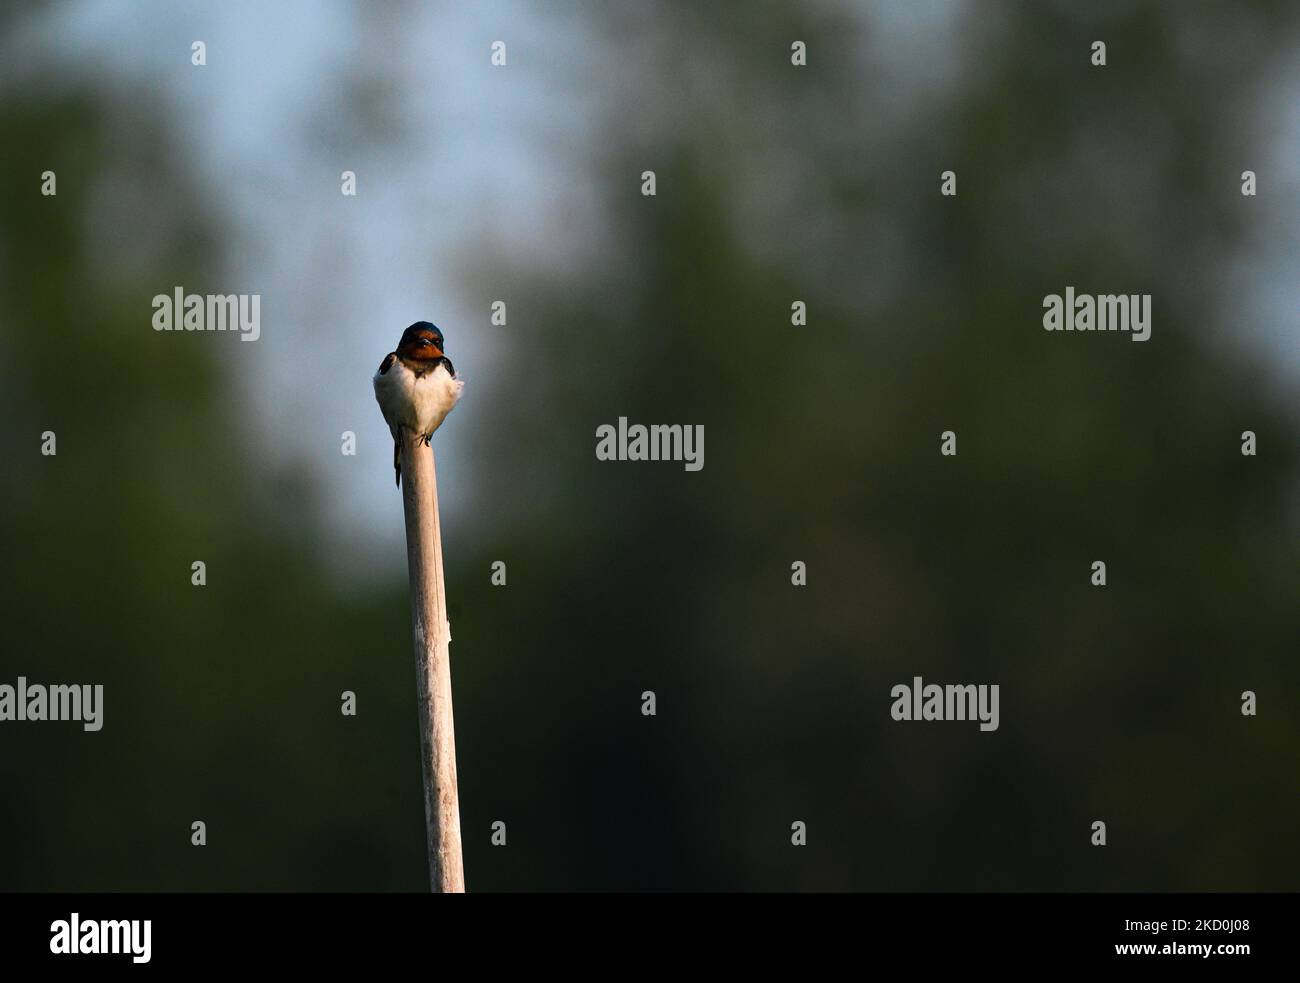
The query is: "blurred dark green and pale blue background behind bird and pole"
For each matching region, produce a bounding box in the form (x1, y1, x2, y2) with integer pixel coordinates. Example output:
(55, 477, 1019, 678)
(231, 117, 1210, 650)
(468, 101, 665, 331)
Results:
(0, 0, 1300, 891)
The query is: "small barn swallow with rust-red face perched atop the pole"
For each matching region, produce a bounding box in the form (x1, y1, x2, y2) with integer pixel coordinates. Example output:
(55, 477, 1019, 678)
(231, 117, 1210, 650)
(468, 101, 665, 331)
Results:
(374, 321, 465, 488)
